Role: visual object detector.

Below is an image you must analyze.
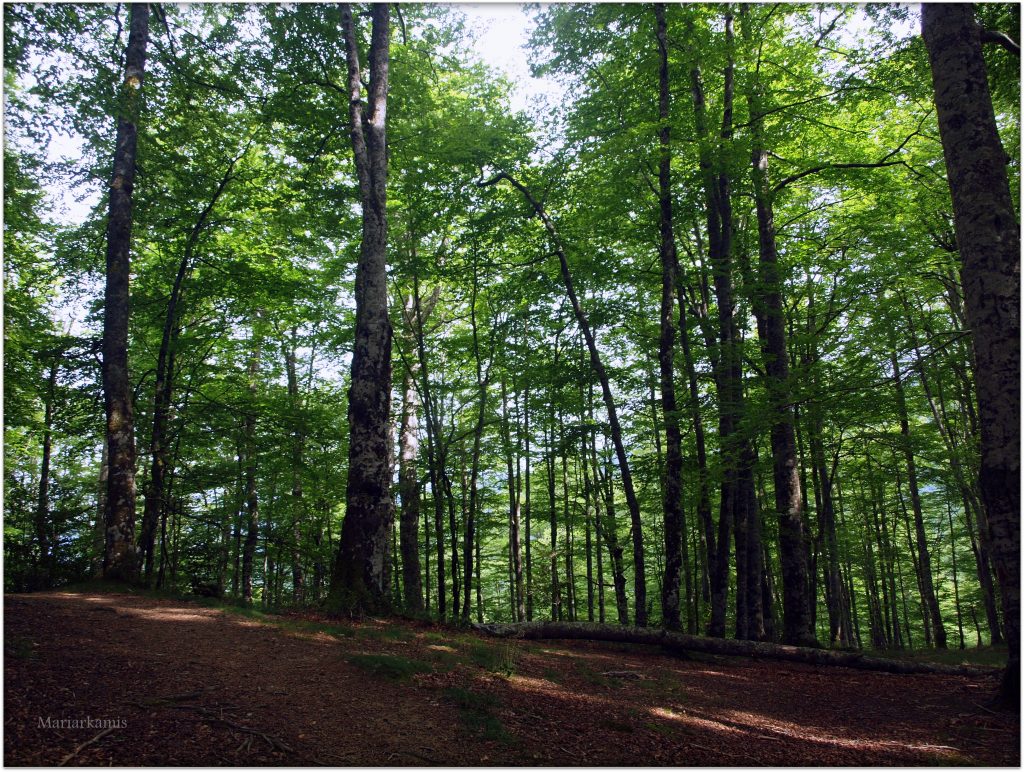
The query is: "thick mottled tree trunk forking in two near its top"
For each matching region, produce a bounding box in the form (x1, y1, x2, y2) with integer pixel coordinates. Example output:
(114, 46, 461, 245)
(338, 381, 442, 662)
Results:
(328, 3, 391, 613)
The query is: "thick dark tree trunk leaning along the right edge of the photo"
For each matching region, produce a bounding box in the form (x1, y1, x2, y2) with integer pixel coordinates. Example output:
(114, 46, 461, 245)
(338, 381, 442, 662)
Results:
(922, 4, 1021, 710)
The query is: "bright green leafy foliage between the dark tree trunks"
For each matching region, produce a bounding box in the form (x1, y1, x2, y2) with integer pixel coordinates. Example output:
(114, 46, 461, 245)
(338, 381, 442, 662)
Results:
(3, 4, 1020, 659)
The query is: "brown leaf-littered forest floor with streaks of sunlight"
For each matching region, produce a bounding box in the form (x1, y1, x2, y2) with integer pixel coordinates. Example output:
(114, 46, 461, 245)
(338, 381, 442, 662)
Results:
(4, 592, 1020, 767)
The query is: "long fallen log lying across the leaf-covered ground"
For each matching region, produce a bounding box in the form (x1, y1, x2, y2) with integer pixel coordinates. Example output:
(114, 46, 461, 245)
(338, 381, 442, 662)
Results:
(473, 621, 999, 676)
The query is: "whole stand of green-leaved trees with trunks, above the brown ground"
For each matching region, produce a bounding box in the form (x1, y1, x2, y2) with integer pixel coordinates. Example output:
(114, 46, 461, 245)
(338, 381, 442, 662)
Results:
(3, 3, 1020, 700)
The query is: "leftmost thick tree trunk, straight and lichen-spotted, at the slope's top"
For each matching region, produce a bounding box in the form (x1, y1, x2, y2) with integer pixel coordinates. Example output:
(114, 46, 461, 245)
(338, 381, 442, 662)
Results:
(102, 3, 150, 582)
